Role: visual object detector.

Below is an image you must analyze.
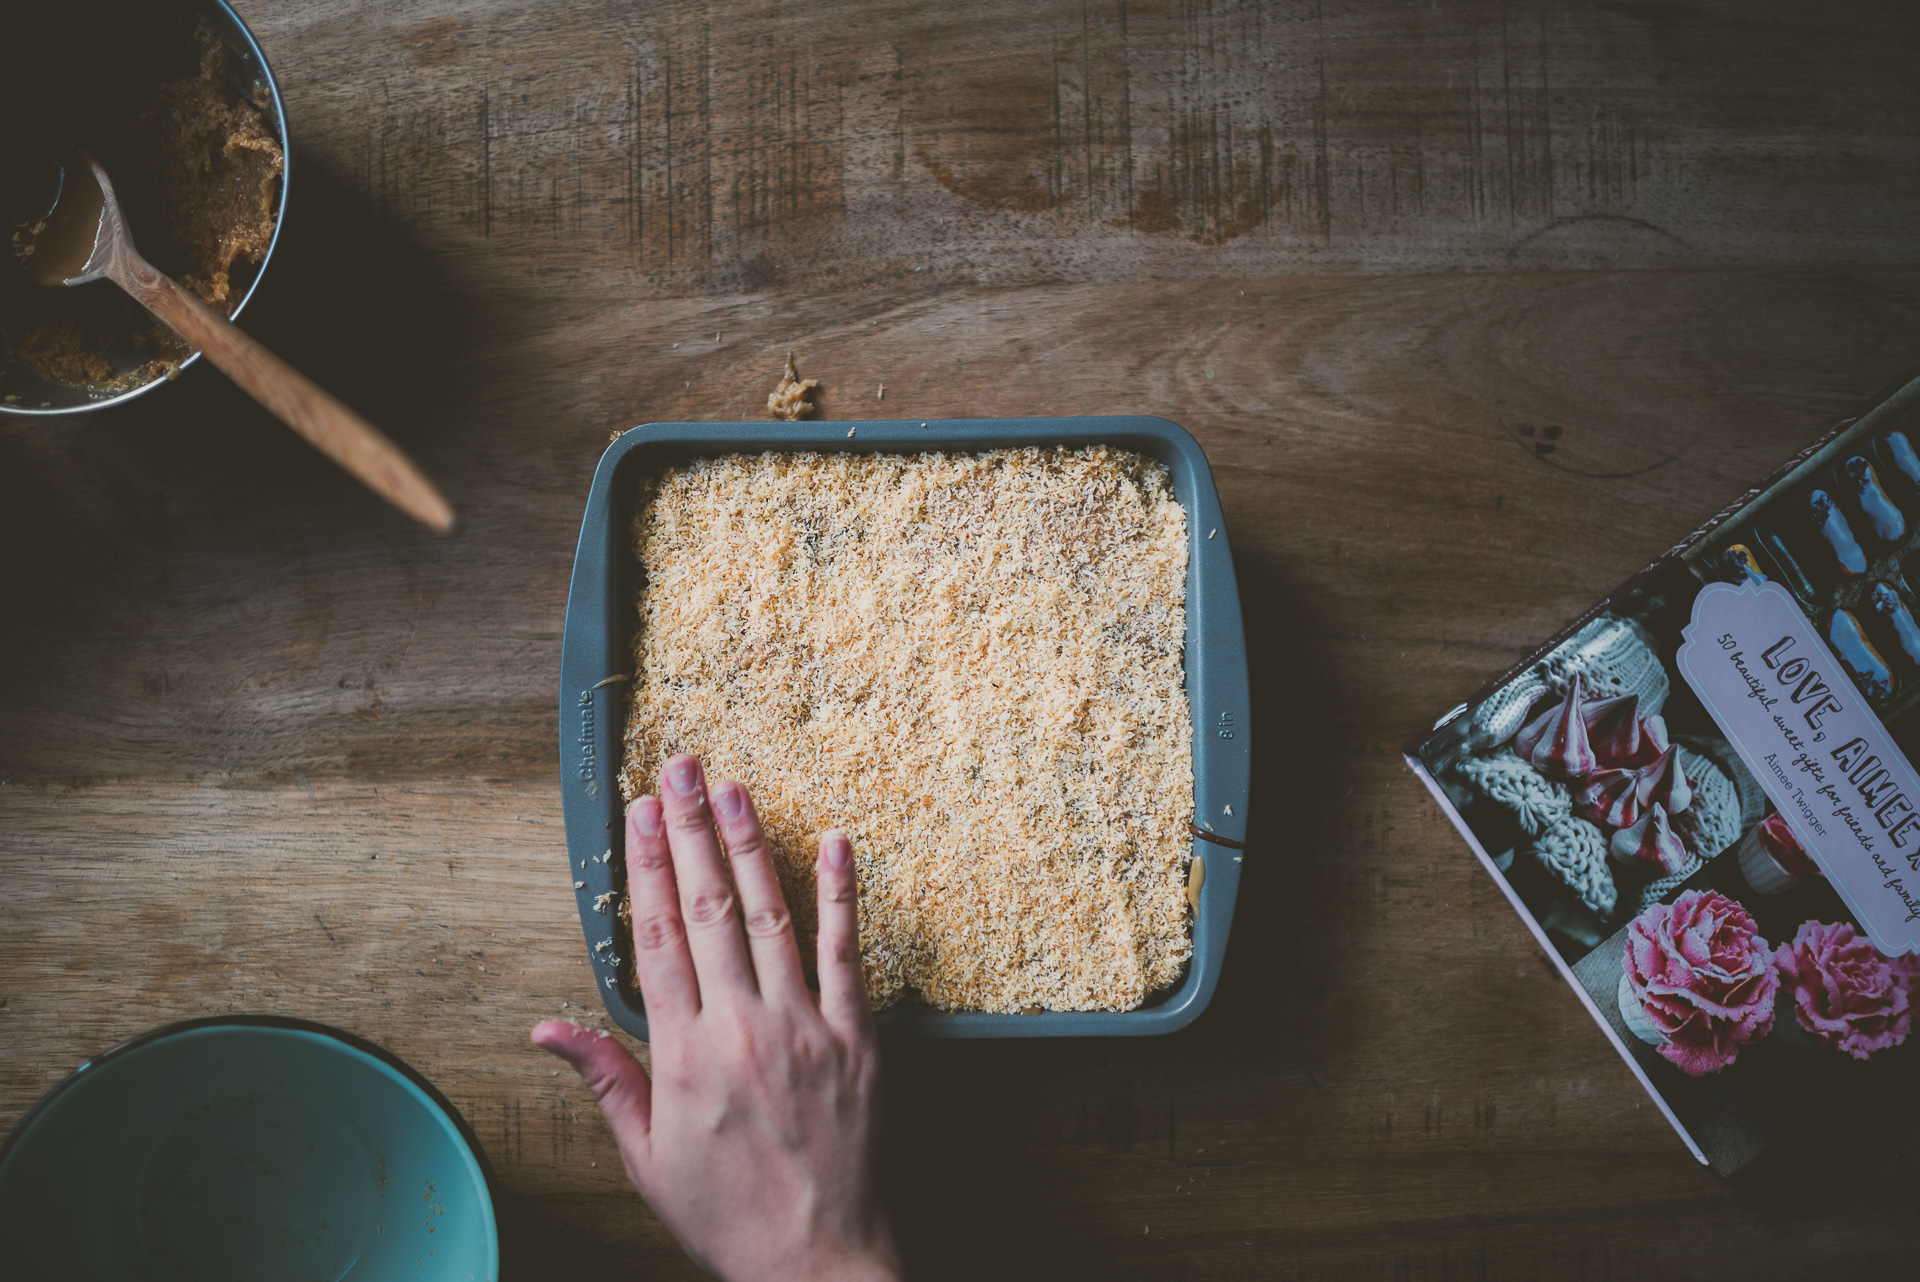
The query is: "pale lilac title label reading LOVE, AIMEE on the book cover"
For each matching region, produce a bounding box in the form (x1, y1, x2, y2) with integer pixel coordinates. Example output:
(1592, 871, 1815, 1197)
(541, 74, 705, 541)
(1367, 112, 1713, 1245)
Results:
(1674, 583, 1920, 956)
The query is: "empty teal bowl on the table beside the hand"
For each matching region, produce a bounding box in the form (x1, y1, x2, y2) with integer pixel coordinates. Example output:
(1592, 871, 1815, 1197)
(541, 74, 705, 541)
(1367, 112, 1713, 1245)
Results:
(0, 1017, 499, 1282)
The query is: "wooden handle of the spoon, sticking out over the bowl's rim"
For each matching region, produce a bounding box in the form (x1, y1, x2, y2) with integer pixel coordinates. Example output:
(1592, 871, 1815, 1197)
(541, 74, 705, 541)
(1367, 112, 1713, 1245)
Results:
(104, 244, 453, 534)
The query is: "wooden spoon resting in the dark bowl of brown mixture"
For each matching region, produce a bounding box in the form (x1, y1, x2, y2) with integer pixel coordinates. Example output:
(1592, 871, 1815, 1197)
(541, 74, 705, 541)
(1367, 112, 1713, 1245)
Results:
(13, 155, 453, 534)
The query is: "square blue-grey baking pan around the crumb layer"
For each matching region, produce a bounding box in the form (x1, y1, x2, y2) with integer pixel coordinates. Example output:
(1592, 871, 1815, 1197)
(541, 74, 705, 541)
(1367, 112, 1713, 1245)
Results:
(559, 416, 1252, 1038)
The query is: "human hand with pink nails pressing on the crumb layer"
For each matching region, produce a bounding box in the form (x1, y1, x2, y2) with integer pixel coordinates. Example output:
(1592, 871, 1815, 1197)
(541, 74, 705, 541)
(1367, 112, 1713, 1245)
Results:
(534, 756, 900, 1282)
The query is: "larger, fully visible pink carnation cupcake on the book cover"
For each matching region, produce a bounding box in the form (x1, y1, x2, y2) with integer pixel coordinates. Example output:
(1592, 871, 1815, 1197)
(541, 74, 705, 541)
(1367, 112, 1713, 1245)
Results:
(1619, 890, 1780, 1077)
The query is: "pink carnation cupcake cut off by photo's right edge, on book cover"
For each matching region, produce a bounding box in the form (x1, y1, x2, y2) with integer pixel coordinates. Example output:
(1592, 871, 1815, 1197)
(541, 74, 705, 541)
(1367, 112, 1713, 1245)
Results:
(1774, 921, 1920, 1059)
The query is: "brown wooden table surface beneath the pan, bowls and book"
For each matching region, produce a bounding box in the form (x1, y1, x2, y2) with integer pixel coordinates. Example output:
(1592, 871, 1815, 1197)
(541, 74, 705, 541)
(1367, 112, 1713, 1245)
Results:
(0, 0, 1920, 1278)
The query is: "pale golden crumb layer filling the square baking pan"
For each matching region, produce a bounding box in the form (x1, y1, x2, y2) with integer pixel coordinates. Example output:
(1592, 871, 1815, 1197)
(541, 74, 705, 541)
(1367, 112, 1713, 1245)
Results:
(620, 447, 1192, 1011)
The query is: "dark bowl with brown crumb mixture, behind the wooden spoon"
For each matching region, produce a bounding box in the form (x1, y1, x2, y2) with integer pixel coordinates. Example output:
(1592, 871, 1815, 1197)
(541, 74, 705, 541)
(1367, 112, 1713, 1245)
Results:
(0, 4, 286, 405)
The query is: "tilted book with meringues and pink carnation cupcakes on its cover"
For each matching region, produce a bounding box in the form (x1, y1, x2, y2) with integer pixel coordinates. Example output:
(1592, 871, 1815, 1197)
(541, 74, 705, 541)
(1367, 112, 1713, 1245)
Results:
(1407, 370, 1920, 1175)
